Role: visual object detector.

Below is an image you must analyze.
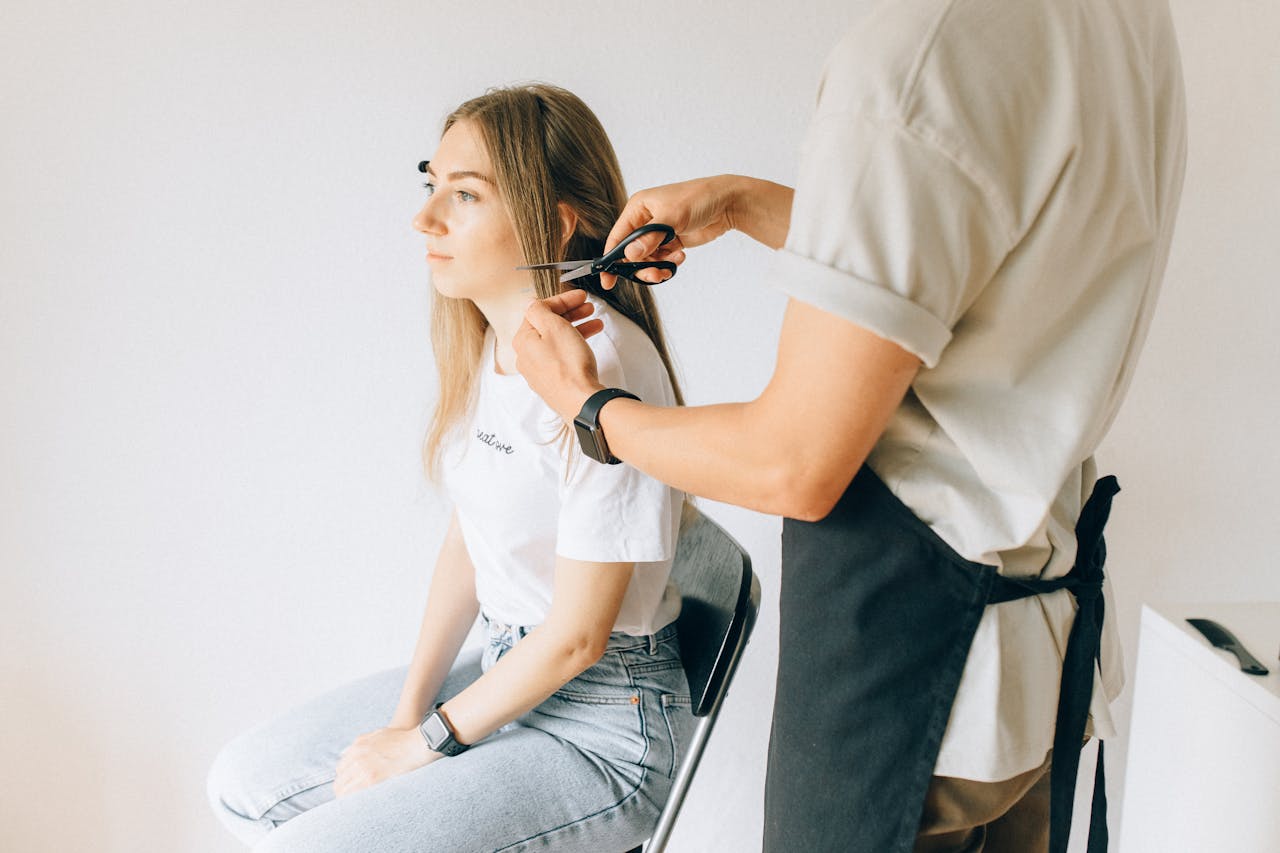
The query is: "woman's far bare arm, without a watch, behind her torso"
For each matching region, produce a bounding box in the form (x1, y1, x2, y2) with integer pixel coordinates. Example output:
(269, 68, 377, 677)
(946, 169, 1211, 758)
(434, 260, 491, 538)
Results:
(389, 512, 480, 729)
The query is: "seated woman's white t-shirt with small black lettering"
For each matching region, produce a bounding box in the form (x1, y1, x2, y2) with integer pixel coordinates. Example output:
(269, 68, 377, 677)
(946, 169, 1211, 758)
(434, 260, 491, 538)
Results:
(442, 298, 684, 635)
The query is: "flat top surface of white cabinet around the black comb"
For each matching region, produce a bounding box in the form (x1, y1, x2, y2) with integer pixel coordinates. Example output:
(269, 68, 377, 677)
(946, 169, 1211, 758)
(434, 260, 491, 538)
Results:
(1142, 602, 1280, 724)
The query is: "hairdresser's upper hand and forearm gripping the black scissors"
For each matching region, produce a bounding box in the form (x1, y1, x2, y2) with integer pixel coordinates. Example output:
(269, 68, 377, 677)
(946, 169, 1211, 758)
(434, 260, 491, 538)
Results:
(600, 174, 794, 289)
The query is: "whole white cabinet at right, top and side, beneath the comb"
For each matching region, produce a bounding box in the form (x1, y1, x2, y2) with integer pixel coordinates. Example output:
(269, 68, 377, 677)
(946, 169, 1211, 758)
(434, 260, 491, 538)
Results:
(1117, 602, 1280, 853)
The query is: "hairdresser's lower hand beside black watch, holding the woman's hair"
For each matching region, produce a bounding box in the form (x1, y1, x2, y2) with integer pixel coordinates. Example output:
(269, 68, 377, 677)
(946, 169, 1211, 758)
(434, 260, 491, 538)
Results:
(512, 291, 604, 424)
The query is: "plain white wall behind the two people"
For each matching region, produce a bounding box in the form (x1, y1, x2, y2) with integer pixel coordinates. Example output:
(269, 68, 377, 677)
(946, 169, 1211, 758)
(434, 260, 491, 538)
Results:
(0, 0, 1280, 853)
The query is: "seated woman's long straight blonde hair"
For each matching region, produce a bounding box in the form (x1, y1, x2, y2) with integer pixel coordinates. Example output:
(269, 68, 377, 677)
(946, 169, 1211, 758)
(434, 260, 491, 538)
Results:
(422, 83, 684, 479)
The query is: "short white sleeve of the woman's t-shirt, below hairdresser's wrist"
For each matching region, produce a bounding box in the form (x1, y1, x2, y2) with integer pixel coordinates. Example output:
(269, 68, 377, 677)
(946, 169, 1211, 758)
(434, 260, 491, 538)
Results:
(556, 324, 680, 562)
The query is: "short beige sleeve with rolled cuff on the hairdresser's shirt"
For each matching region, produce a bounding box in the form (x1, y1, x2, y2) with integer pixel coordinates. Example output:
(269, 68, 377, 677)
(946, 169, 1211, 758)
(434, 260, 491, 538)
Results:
(772, 108, 1011, 368)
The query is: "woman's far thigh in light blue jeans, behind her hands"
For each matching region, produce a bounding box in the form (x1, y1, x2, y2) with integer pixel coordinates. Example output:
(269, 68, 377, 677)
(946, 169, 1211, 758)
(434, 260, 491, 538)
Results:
(209, 652, 480, 843)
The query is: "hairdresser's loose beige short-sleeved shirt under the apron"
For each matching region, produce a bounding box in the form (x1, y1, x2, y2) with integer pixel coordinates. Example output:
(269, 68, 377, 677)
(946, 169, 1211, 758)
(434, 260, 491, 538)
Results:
(773, 0, 1185, 781)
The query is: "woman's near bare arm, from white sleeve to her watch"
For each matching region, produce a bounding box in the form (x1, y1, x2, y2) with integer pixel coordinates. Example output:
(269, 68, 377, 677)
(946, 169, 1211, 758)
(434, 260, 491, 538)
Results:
(440, 557, 635, 743)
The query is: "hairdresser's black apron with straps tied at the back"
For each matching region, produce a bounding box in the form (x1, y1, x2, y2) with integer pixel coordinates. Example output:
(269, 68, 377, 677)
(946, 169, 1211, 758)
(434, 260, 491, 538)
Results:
(764, 466, 1120, 853)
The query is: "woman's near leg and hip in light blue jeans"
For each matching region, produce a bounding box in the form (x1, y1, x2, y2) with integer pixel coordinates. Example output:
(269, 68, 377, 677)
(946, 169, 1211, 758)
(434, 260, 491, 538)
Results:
(240, 630, 691, 853)
